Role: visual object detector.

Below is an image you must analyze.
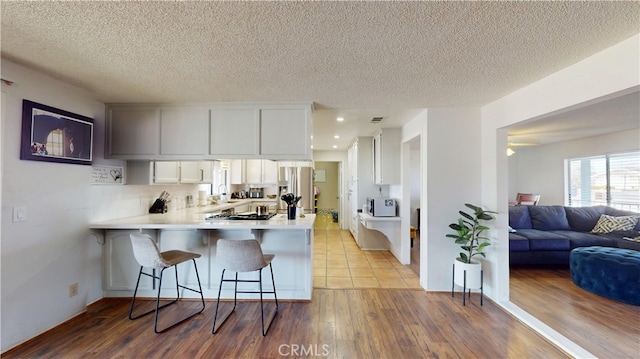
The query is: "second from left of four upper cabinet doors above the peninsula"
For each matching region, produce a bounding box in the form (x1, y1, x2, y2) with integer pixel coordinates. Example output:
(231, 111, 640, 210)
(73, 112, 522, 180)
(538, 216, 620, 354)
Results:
(160, 106, 209, 156)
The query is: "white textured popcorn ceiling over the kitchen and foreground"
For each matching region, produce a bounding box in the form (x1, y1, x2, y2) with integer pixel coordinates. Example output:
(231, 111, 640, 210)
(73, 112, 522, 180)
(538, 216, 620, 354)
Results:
(1, 1, 640, 150)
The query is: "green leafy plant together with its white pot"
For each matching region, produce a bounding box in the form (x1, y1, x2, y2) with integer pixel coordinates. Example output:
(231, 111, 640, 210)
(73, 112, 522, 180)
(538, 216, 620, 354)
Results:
(447, 203, 497, 290)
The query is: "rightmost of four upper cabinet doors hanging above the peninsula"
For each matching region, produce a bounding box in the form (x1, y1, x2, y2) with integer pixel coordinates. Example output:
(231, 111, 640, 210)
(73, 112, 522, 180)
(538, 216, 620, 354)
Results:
(260, 106, 312, 159)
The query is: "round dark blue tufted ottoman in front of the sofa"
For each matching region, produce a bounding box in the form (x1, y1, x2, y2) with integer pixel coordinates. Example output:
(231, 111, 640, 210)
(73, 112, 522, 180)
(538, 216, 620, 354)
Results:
(569, 246, 640, 305)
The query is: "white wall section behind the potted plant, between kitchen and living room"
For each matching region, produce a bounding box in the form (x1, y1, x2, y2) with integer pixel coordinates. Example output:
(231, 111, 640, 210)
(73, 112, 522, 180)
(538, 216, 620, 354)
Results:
(401, 108, 481, 291)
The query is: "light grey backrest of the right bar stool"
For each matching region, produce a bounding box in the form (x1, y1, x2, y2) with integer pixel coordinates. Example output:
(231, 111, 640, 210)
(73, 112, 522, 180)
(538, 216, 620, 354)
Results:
(216, 239, 270, 272)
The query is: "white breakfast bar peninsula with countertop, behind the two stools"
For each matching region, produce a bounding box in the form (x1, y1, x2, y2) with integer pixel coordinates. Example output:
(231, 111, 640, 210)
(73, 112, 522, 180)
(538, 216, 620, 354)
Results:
(90, 208, 315, 300)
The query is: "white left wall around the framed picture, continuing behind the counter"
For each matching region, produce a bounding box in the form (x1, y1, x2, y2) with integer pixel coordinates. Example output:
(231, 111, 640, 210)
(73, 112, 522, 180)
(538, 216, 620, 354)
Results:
(0, 59, 202, 352)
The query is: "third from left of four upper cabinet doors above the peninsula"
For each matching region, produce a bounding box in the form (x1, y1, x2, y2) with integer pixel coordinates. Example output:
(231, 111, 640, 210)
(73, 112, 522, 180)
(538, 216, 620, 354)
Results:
(209, 107, 260, 158)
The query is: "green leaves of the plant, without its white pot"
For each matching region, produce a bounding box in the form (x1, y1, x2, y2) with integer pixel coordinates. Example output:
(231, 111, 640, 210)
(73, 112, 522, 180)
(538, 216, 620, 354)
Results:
(447, 203, 497, 263)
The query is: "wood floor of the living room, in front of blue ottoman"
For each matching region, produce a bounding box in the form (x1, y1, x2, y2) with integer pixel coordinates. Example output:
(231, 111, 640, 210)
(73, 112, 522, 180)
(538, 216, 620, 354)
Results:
(510, 268, 640, 358)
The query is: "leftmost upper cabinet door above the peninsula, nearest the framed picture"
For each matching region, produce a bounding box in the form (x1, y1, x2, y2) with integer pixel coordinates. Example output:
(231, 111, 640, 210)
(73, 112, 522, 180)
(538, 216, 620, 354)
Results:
(105, 105, 160, 159)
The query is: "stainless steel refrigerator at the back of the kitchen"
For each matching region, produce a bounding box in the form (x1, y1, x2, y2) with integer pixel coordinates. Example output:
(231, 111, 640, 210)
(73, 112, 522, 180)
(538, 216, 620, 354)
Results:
(278, 167, 315, 213)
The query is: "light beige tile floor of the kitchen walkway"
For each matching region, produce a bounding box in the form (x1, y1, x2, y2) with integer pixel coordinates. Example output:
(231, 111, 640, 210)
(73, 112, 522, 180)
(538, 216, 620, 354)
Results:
(313, 213, 421, 289)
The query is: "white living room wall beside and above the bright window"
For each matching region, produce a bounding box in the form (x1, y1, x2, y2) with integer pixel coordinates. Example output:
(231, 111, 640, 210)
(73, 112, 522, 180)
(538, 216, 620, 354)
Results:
(509, 129, 640, 205)
